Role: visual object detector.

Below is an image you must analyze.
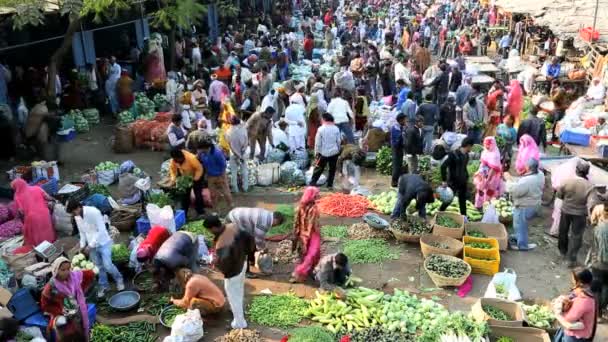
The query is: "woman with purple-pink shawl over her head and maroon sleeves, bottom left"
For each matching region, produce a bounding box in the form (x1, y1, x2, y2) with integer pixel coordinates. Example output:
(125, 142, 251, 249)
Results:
(40, 256, 95, 342)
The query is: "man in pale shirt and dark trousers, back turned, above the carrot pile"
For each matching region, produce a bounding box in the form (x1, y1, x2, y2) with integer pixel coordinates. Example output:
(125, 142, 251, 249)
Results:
(310, 113, 342, 189)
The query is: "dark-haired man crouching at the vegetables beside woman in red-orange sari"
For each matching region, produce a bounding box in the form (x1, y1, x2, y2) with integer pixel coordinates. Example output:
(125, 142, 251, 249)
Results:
(314, 253, 352, 291)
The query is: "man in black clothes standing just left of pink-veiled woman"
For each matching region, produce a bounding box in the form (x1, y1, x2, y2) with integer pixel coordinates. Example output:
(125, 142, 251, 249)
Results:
(439, 137, 473, 216)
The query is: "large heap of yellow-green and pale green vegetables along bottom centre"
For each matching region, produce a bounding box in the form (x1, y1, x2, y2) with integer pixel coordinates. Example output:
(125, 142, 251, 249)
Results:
(306, 287, 487, 342)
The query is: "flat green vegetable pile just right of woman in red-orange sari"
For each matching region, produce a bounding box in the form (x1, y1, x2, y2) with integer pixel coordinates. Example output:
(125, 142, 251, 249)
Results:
(343, 239, 399, 264)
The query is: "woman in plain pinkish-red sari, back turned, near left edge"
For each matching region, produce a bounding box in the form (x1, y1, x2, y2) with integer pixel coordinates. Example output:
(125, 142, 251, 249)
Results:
(11, 178, 57, 254)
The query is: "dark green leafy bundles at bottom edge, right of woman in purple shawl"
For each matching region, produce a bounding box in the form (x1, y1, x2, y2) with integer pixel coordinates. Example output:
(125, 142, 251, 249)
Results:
(90, 322, 157, 342)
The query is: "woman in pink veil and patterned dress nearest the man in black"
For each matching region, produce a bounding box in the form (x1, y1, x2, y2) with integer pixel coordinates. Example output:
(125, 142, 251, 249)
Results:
(473, 137, 504, 208)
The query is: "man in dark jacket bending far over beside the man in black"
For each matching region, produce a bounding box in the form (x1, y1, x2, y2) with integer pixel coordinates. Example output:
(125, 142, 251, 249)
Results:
(391, 174, 435, 219)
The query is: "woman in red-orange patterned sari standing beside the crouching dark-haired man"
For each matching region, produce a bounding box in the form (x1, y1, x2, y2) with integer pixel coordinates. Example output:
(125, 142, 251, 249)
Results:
(290, 186, 321, 283)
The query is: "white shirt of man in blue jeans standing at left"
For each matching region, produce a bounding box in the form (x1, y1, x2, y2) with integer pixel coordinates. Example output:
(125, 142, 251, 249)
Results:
(75, 206, 112, 248)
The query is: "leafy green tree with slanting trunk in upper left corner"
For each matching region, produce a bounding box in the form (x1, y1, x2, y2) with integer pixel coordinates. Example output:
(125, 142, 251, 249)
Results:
(0, 0, 207, 102)
